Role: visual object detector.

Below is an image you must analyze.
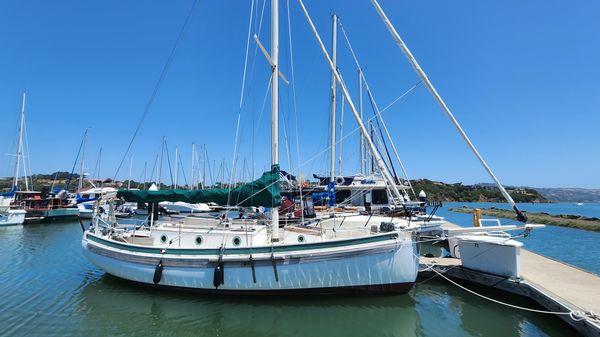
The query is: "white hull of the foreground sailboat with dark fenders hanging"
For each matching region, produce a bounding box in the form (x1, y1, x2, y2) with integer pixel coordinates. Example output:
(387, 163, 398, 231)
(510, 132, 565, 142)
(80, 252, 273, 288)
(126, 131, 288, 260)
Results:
(82, 234, 418, 294)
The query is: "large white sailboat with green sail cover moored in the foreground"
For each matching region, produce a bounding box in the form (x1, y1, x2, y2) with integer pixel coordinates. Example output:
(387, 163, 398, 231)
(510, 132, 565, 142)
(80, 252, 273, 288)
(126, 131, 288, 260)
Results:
(81, 0, 426, 295)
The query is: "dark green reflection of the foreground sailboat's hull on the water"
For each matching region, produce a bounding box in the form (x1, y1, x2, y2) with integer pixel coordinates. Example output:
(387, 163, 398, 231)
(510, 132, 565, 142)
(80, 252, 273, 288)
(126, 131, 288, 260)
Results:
(80, 275, 420, 336)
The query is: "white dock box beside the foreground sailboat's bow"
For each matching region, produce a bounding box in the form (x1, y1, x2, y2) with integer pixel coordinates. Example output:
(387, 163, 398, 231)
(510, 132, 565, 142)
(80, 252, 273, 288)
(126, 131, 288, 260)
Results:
(456, 235, 523, 278)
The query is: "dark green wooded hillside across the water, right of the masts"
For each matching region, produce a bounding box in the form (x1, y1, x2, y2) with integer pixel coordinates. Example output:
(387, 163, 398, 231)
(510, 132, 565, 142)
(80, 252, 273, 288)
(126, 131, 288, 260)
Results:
(411, 179, 549, 202)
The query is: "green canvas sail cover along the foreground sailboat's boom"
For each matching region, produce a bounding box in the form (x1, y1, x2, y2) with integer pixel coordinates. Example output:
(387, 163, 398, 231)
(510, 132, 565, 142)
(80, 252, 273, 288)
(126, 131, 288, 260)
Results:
(117, 166, 281, 207)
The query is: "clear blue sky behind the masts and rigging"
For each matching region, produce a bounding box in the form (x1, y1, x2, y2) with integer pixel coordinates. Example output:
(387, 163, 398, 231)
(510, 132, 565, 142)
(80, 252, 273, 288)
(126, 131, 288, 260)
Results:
(0, 0, 600, 188)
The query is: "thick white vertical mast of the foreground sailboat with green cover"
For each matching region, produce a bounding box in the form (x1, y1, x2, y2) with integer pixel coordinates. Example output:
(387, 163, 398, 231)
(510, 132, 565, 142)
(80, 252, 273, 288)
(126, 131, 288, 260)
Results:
(271, 0, 279, 242)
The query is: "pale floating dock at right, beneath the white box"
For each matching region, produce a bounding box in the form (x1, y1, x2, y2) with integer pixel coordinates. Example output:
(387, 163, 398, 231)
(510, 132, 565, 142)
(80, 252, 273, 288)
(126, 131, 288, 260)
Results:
(419, 222, 600, 337)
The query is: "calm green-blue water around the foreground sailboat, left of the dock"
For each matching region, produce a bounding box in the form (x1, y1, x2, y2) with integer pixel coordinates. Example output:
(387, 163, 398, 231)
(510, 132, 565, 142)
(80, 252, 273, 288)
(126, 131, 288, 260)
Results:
(0, 219, 575, 337)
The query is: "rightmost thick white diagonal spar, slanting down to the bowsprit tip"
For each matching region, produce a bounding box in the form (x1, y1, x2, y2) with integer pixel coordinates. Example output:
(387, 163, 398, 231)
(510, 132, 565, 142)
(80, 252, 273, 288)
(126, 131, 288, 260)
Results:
(371, 0, 527, 222)
